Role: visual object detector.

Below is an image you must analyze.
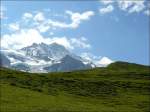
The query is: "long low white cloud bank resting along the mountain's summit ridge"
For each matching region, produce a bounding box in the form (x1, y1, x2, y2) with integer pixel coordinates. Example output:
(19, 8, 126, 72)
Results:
(1, 29, 90, 49)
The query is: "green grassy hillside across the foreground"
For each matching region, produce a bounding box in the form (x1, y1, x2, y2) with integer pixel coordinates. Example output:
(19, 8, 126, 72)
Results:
(0, 62, 150, 112)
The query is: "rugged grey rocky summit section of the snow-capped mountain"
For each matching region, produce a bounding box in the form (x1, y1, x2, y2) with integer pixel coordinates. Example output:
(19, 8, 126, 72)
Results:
(21, 43, 70, 61)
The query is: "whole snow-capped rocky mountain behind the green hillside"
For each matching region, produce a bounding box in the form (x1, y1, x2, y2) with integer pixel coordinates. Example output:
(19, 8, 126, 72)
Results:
(0, 43, 112, 72)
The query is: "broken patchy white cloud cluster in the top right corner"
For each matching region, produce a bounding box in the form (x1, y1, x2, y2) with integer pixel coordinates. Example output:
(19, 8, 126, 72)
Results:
(99, 0, 149, 15)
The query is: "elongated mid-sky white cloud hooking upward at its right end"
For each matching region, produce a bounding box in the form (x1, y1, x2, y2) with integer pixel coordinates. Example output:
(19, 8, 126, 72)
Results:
(31, 11, 94, 32)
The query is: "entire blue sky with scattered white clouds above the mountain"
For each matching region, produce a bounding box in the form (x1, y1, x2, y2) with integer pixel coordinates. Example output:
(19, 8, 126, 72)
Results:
(1, 0, 150, 65)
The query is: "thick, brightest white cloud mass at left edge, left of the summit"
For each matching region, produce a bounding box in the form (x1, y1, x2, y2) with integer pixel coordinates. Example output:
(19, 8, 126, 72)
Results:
(1, 29, 43, 49)
